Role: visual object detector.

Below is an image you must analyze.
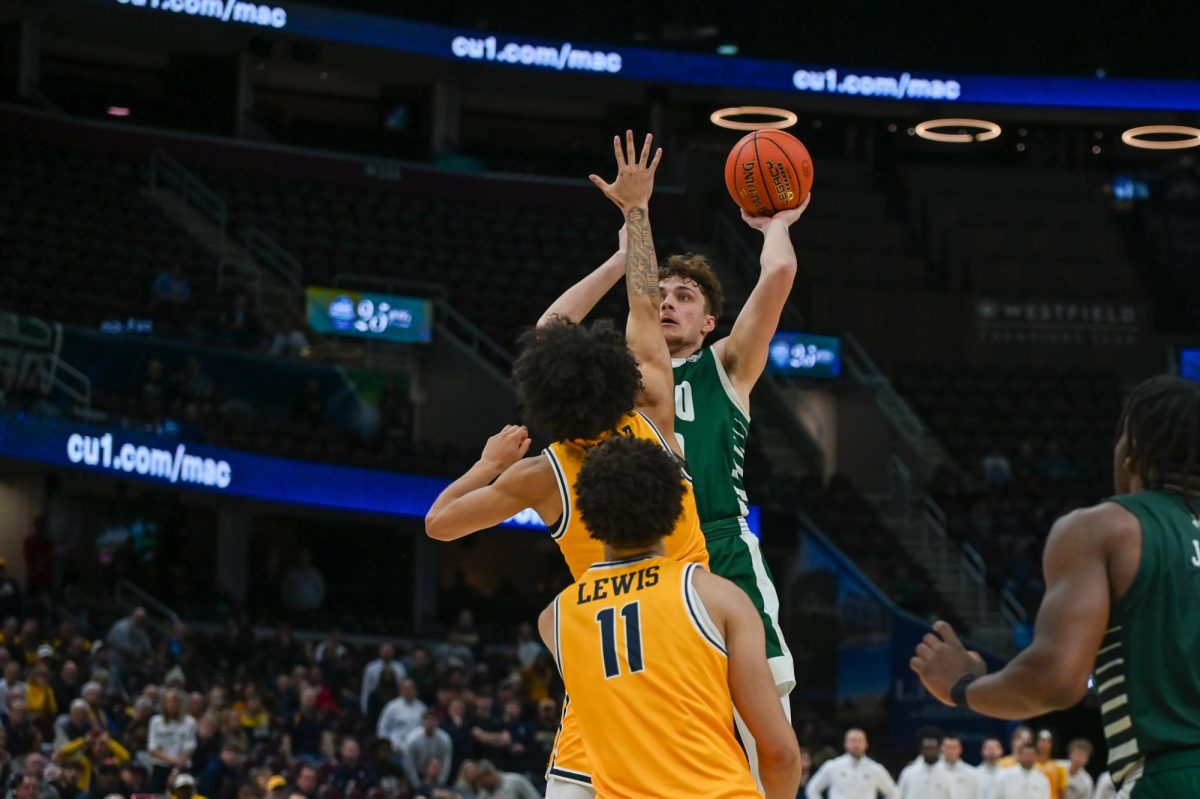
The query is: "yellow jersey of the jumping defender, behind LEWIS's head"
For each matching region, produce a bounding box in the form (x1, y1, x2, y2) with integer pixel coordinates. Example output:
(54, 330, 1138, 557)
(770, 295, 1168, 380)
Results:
(545, 410, 708, 579)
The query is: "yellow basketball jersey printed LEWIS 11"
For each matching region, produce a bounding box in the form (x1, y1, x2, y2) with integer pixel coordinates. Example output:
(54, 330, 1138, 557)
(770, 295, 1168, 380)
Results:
(554, 555, 762, 799)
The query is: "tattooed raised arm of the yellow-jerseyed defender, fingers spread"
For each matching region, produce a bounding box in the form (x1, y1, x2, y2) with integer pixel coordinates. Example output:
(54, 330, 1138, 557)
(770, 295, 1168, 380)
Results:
(589, 131, 674, 431)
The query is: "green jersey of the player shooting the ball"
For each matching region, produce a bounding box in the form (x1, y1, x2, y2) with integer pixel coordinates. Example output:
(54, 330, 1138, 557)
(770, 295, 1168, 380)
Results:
(672, 347, 750, 525)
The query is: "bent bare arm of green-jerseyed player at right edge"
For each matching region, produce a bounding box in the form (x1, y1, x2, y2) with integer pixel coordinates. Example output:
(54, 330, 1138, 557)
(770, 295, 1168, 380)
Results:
(910, 503, 1141, 719)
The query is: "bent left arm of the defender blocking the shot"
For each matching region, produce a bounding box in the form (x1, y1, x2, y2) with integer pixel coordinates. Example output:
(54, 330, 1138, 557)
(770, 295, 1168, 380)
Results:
(425, 457, 558, 541)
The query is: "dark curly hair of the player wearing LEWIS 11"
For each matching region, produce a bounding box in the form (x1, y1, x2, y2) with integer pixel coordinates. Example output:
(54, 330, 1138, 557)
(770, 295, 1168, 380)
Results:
(575, 435, 684, 549)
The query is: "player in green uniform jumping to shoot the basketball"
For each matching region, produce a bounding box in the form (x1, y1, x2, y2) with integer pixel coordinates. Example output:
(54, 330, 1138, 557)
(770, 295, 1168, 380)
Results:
(539, 193, 808, 777)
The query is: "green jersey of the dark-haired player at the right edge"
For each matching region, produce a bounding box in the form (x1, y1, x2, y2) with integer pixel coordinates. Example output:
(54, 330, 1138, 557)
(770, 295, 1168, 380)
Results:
(1094, 491, 1200, 785)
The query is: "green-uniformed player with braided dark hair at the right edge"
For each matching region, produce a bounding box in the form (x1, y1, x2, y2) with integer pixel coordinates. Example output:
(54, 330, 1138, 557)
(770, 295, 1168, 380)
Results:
(912, 377, 1200, 799)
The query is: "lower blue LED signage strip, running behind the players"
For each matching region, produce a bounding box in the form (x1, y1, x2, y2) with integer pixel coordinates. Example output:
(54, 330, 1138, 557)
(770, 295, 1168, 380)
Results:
(0, 413, 758, 534)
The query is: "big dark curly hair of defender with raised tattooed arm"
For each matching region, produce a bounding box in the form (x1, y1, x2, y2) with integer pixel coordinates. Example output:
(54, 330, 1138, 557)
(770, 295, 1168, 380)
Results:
(512, 319, 642, 441)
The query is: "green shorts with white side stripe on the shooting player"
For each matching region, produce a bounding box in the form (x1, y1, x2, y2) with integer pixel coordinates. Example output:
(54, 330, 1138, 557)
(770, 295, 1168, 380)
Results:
(701, 518, 796, 696)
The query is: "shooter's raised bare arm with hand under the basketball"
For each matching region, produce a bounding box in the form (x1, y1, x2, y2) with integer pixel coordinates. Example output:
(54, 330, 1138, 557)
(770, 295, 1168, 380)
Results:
(713, 194, 812, 407)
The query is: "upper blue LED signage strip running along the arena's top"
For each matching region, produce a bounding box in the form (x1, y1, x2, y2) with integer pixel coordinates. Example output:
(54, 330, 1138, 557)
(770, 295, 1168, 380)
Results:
(92, 0, 1200, 110)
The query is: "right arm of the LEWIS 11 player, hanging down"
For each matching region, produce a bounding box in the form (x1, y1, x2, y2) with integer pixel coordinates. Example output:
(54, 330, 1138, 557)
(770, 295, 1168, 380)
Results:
(694, 569, 802, 799)
